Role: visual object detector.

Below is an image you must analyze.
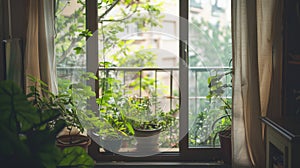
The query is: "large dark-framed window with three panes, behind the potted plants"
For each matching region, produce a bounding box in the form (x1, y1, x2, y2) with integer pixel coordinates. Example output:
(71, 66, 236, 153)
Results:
(56, 0, 231, 161)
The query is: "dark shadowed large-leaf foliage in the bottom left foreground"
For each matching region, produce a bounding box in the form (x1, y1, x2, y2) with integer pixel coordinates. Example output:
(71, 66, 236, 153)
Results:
(0, 81, 93, 167)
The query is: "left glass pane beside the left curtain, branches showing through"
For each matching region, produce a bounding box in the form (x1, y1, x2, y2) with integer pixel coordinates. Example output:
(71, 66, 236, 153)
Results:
(55, 0, 86, 82)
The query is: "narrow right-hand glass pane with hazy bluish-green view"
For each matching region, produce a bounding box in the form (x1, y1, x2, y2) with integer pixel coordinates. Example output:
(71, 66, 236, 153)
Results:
(188, 0, 232, 148)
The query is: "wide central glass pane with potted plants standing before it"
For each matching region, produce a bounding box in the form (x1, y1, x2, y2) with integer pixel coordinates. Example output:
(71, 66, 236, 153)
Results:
(93, 0, 179, 157)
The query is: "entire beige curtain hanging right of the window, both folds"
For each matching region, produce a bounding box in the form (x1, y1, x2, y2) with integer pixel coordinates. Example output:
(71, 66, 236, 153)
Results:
(232, 0, 282, 168)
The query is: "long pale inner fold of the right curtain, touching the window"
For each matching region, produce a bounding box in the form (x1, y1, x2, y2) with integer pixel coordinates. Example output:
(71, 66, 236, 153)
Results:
(232, 0, 263, 167)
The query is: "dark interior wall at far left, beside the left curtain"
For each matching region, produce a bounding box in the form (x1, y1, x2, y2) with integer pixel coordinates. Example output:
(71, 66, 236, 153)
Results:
(0, 0, 29, 80)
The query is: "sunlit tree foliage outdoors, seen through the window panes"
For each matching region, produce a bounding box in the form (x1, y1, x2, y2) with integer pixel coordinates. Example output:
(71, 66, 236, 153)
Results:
(56, 0, 231, 148)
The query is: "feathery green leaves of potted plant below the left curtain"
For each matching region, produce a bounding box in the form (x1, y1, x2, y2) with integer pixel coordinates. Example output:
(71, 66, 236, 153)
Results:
(28, 73, 95, 133)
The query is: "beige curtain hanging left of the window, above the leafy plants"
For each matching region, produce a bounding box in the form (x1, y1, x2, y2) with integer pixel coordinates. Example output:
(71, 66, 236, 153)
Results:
(24, 0, 57, 93)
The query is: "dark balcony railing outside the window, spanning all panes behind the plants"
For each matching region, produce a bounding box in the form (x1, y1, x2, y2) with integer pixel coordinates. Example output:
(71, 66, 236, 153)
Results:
(57, 67, 231, 147)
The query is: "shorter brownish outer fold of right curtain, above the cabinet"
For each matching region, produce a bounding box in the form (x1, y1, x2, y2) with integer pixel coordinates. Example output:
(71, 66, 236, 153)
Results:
(257, 0, 283, 117)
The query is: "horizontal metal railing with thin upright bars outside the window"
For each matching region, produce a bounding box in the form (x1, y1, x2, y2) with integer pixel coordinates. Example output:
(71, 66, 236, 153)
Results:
(57, 67, 231, 113)
